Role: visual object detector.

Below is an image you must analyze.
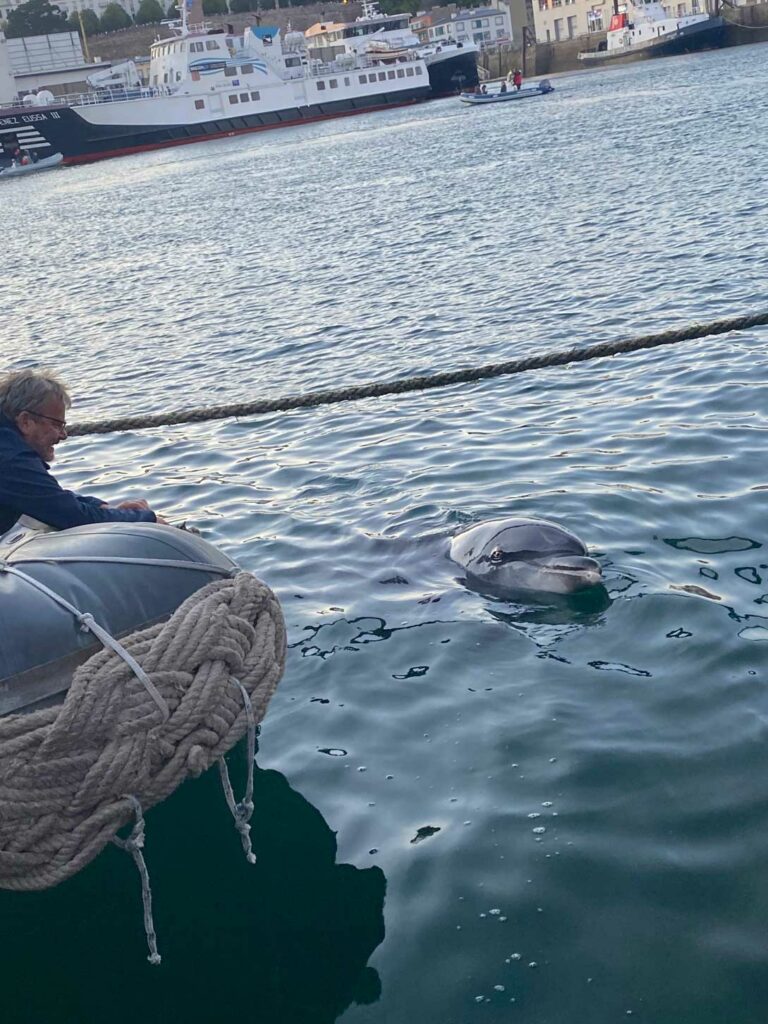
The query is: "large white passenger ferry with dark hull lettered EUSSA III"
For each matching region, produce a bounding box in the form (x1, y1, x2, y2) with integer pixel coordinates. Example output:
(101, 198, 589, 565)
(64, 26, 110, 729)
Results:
(0, 2, 431, 164)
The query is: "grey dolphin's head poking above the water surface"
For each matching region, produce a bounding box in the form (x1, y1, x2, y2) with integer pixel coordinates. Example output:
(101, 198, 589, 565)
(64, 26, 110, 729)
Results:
(450, 518, 603, 597)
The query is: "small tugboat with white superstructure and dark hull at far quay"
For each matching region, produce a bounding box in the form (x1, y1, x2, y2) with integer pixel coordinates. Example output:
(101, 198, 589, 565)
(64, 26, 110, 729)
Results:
(579, 0, 725, 65)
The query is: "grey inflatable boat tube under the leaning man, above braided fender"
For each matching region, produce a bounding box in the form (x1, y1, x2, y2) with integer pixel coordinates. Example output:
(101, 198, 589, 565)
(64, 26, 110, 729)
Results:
(0, 523, 238, 715)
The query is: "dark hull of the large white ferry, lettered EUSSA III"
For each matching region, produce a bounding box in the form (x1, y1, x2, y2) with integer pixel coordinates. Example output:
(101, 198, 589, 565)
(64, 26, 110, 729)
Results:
(0, 85, 431, 164)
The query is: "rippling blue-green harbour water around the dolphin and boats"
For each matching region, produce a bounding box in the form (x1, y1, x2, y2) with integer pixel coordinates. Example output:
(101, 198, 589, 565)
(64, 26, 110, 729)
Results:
(0, 46, 768, 1024)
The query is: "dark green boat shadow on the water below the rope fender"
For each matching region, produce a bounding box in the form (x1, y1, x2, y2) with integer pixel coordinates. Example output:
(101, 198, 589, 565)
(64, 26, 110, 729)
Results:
(0, 758, 386, 1024)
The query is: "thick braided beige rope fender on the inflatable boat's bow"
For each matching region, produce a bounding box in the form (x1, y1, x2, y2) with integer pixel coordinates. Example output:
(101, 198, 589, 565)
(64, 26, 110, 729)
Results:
(0, 571, 286, 890)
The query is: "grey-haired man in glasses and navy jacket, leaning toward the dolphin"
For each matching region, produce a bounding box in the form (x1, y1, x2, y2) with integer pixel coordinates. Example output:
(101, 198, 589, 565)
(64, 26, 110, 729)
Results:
(0, 370, 165, 538)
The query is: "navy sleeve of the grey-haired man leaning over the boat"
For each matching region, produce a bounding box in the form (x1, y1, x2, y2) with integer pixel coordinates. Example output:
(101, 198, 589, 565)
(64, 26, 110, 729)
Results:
(0, 451, 156, 529)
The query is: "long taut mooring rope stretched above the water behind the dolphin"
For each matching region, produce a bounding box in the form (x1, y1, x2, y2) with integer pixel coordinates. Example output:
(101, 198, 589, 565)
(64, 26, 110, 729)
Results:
(69, 311, 768, 436)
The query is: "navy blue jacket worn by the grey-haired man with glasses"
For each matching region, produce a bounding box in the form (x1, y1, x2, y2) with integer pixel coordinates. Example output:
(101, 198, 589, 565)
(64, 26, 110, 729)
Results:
(0, 417, 155, 535)
